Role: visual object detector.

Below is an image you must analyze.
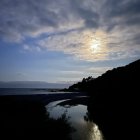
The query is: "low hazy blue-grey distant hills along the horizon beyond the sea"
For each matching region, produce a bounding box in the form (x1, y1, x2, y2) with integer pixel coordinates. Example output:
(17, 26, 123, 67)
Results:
(0, 81, 70, 89)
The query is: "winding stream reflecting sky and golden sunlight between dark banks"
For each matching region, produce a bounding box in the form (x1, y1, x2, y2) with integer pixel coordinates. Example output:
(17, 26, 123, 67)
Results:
(47, 100, 103, 140)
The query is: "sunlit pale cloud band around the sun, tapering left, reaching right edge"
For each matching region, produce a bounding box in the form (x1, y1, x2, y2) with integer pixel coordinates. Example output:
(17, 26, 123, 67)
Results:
(33, 29, 140, 62)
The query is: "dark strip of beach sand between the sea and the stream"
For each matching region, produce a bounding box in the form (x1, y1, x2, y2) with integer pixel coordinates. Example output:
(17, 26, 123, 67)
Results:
(0, 93, 86, 105)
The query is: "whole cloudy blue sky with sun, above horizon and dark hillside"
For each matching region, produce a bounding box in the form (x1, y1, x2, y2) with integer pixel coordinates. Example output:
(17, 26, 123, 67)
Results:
(0, 0, 140, 83)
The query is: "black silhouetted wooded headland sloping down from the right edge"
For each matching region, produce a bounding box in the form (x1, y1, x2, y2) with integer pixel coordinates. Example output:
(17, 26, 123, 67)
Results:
(69, 60, 140, 140)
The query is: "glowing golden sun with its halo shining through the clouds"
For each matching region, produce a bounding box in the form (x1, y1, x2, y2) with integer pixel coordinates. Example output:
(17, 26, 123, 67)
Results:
(79, 30, 110, 61)
